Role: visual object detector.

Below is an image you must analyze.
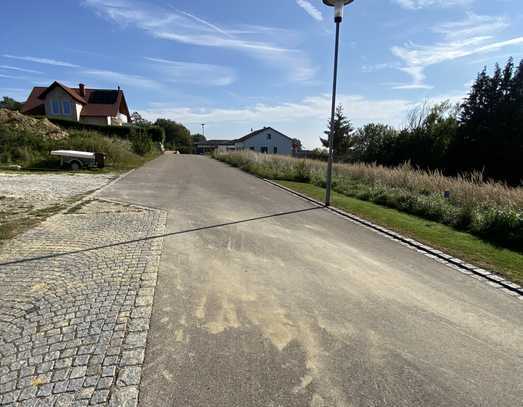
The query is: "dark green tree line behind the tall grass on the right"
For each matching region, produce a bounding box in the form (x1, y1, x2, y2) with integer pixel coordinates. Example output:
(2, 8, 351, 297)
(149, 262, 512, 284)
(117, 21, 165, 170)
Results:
(321, 58, 523, 185)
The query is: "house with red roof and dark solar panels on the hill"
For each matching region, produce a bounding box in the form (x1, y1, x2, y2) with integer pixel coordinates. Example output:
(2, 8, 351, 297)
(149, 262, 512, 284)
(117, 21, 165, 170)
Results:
(22, 81, 131, 126)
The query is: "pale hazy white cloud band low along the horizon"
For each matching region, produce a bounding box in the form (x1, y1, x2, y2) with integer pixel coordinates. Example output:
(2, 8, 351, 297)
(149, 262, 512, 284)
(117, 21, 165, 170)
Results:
(140, 94, 416, 148)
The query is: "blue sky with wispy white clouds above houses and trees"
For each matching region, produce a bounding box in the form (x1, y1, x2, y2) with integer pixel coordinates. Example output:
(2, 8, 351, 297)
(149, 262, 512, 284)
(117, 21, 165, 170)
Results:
(0, 0, 523, 147)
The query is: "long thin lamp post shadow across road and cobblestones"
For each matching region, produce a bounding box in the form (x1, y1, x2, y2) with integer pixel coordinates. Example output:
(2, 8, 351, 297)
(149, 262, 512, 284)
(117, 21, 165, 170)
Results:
(0, 206, 323, 267)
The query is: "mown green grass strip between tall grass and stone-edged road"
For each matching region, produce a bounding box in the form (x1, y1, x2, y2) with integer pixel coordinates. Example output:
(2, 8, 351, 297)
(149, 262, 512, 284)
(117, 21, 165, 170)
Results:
(276, 181, 523, 284)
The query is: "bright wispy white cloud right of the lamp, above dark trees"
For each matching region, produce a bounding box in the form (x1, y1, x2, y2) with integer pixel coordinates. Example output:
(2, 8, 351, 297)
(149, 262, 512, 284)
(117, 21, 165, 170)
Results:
(391, 13, 523, 89)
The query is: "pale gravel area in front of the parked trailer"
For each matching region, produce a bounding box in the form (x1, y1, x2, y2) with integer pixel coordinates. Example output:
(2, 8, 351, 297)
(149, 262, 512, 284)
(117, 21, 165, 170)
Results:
(0, 172, 116, 228)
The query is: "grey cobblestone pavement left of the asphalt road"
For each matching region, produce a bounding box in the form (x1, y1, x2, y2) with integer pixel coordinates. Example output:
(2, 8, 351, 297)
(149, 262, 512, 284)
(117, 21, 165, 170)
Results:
(0, 201, 166, 406)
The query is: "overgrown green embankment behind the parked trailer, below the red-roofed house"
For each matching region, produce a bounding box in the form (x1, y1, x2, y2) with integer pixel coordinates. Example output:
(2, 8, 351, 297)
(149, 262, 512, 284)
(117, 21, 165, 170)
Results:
(0, 109, 158, 170)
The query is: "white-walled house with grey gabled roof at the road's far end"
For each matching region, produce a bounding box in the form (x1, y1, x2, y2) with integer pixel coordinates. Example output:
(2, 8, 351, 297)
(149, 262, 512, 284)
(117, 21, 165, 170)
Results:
(235, 127, 299, 155)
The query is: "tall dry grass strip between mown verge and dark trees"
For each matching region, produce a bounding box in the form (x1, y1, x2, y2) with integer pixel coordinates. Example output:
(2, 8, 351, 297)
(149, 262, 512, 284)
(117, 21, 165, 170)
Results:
(215, 151, 523, 251)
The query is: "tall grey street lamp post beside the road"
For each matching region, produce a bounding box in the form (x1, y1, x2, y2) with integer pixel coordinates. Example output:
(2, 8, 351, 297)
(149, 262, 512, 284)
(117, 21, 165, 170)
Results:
(323, 0, 354, 206)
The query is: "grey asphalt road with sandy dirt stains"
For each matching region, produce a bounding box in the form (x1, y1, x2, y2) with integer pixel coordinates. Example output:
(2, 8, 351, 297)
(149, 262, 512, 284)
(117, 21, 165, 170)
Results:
(100, 155, 523, 407)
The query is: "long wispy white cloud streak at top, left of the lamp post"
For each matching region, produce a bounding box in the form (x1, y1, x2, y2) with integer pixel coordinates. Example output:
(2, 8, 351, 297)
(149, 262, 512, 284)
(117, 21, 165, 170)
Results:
(83, 0, 316, 81)
